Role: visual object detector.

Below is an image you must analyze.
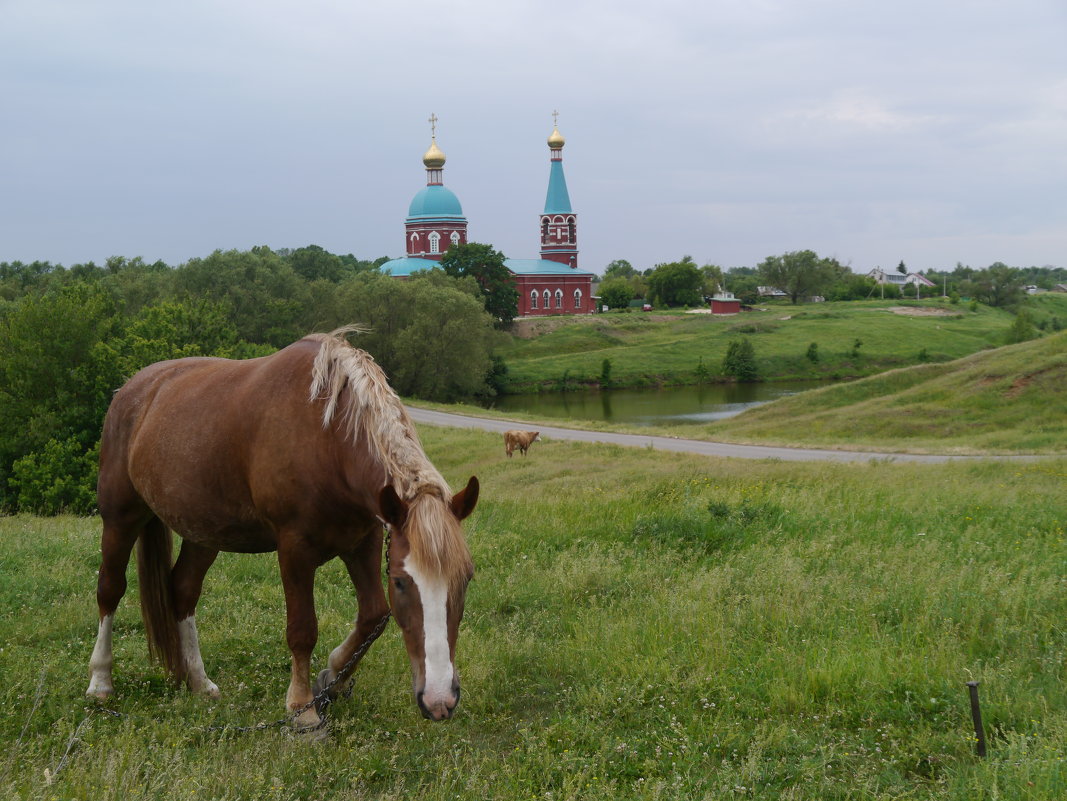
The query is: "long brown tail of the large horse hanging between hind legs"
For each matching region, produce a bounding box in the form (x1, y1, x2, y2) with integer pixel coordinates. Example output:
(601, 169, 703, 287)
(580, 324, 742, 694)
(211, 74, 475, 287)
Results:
(137, 517, 186, 682)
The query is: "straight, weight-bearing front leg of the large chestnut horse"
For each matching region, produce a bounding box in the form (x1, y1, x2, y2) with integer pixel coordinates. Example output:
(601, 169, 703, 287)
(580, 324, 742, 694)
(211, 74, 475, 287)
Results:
(277, 541, 322, 728)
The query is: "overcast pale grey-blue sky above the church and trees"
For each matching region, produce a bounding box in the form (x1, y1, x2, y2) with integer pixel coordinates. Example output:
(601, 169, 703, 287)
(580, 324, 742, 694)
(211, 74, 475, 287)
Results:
(0, 0, 1067, 272)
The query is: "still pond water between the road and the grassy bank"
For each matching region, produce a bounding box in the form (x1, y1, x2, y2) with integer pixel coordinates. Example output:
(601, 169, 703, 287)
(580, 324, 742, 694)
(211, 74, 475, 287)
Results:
(487, 381, 826, 426)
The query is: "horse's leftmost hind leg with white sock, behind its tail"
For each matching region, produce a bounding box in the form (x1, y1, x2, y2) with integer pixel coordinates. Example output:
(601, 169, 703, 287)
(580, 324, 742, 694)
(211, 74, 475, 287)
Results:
(85, 519, 141, 699)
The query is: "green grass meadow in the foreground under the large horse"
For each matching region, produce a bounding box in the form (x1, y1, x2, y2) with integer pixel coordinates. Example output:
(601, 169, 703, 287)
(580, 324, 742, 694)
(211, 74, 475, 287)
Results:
(0, 428, 1067, 801)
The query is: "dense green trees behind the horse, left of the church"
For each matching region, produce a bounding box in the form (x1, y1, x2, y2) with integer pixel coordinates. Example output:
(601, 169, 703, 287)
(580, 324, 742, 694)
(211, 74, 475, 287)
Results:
(0, 245, 514, 513)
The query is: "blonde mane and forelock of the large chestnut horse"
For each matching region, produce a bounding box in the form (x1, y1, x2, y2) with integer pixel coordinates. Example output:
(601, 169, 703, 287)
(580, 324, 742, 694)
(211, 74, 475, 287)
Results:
(306, 325, 472, 584)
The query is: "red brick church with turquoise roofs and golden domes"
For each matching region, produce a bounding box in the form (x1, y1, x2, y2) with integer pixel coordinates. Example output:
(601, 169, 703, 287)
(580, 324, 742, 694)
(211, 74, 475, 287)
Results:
(381, 116, 595, 317)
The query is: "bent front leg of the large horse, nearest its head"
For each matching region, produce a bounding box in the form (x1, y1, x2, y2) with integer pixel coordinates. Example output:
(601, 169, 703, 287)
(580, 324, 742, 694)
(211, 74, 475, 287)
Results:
(316, 526, 389, 698)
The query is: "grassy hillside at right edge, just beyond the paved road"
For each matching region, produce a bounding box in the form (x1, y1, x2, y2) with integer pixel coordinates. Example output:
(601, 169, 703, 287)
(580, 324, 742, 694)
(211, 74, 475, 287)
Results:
(691, 332, 1067, 453)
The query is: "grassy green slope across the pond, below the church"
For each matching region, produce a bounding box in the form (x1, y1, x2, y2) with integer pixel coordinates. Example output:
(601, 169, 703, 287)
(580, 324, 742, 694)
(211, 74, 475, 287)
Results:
(497, 297, 1015, 393)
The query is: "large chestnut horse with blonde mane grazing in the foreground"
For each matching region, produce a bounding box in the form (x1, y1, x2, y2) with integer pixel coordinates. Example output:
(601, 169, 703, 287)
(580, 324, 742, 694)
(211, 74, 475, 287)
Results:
(87, 326, 478, 728)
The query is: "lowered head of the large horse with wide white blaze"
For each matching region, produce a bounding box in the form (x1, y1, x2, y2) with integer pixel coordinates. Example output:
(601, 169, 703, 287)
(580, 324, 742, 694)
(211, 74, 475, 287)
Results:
(379, 477, 478, 720)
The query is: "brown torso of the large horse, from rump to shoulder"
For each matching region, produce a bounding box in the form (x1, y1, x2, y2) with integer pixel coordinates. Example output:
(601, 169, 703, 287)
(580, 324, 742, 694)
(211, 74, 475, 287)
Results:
(98, 339, 354, 550)
